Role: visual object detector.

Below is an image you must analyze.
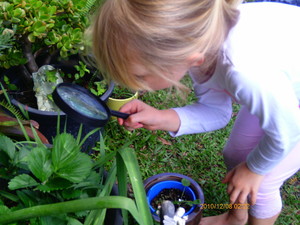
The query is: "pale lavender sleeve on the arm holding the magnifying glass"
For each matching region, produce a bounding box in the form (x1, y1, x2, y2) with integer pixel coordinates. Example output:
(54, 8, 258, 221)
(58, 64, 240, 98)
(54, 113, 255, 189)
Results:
(170, 81, 232, 137)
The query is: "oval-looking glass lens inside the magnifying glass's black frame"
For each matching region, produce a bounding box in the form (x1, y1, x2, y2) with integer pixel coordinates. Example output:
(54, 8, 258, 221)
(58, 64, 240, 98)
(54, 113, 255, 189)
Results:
(57, 86, 108, 120)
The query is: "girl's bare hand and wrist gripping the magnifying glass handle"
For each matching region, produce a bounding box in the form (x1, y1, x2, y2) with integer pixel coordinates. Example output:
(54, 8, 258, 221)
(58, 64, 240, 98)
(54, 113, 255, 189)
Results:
(118, 99, 180, 132)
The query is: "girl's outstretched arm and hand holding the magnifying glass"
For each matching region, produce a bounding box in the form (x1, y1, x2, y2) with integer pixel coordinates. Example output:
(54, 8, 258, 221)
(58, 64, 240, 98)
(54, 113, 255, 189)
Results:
(118, 78, 232, 136)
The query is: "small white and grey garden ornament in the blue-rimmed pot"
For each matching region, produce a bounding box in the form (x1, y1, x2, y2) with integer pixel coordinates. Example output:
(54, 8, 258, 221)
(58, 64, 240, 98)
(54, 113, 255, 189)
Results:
(160, 200, 188, 225)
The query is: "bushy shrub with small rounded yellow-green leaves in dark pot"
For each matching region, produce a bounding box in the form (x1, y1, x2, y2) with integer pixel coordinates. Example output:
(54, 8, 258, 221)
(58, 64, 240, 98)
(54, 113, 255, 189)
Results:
(0, 0, 111, 149)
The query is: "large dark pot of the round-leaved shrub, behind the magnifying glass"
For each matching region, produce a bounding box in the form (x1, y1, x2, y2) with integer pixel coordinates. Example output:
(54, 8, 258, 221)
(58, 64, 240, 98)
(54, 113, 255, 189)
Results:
(2, 65, 114, 152)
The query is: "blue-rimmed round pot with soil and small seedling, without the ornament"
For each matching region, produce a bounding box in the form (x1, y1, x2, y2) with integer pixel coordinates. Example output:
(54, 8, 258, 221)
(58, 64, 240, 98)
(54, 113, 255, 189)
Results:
(144, 173, 204, 225)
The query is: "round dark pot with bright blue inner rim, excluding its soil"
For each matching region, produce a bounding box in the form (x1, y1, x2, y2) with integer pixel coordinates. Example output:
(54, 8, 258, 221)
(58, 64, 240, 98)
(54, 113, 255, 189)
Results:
(144, 173, 204, 225)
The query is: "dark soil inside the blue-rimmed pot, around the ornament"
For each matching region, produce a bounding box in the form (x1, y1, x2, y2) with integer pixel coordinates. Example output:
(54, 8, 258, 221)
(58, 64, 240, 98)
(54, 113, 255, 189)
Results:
(150, 188, 192, 212)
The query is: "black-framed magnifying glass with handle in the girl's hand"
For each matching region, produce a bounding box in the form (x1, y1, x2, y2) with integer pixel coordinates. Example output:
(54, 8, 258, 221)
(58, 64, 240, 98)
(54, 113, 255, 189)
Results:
(52, 83, 130, 127)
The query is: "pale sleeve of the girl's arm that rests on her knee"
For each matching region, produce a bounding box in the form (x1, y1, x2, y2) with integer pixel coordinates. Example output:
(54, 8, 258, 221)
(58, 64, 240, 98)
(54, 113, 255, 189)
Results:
(227, 69, 300, 175)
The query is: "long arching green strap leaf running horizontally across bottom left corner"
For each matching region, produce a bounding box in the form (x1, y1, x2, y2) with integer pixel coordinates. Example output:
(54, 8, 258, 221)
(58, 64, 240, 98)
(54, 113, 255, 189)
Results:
(0, 196, 140, 224)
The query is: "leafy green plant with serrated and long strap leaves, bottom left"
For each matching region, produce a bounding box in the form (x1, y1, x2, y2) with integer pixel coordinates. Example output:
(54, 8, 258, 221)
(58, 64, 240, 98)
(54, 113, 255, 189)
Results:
(0, 87, 152, 225)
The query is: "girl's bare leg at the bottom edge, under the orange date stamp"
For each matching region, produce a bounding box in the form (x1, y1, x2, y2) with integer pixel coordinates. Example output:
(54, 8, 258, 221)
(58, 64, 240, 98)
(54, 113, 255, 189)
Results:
(199, 209, 248, 225)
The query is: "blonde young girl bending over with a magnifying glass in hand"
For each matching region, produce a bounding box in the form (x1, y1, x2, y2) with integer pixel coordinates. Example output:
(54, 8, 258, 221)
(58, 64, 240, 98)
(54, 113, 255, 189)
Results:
(93, 0, 300, 225)
